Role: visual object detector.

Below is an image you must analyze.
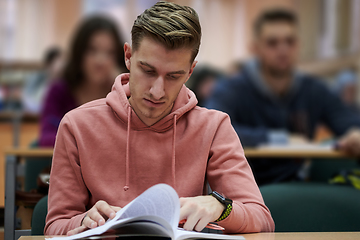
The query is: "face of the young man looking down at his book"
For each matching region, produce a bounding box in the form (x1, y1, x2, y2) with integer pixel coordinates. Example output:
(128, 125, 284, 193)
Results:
(124, 37, 196, 126)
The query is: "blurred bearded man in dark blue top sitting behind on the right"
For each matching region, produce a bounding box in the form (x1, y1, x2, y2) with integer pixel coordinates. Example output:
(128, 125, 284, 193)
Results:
(207, 9, 360, 184)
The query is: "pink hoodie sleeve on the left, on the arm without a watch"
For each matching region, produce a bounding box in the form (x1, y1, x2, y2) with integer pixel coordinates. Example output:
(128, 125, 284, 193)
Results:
(44, 115, 89, 235)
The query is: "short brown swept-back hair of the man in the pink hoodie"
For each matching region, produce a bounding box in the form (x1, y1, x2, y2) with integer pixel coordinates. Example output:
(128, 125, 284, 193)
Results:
(131, 1, 201, 62)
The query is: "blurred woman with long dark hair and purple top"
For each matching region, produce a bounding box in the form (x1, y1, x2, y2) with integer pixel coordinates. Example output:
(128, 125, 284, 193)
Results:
(39, 16, 126, 147)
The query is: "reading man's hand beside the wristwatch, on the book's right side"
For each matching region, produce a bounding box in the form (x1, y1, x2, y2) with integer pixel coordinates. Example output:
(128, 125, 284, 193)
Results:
(179, 196, 225, 232)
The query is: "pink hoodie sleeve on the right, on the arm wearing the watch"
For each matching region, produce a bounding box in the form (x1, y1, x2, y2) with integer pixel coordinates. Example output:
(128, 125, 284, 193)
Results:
(207, 113, 275, 233)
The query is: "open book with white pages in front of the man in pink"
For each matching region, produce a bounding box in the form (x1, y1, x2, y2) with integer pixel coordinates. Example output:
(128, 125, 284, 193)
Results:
(47, 184, 245, 240)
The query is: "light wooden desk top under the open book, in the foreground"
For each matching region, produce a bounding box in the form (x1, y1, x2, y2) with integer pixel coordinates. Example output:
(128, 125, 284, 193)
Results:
(20, 232, 360, 240)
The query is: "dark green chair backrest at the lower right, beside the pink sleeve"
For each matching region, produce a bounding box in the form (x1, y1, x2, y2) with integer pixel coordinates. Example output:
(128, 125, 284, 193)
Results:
(260, 183, 360, 232)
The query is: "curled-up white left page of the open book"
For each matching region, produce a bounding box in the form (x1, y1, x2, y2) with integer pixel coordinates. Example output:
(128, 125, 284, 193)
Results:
(47, 184, 180, 240)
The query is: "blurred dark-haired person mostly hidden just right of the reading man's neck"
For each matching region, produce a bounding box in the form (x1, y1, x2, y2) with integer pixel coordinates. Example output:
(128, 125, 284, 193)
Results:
(186, 65, 222, 107)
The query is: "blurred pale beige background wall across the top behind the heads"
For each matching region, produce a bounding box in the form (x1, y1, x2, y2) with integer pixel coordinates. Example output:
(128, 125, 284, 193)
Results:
(0, 0, 360, 69)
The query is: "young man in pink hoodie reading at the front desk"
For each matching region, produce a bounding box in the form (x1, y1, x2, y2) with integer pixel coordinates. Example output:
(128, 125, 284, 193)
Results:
(45, 2, 274, 235)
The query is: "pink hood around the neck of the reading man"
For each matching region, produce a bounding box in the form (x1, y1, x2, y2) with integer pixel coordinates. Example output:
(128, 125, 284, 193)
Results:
(106, 73, 198, 132)
